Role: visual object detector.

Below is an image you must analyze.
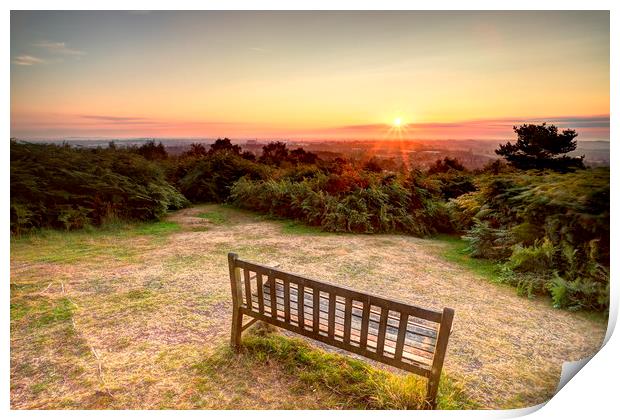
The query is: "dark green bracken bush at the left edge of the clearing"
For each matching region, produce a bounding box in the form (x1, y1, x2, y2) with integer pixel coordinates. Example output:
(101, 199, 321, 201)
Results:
(11, 141, 187, 234)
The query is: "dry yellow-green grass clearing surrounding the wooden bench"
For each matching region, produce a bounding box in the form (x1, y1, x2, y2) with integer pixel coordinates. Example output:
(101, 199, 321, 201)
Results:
(11, 205, 606, 409)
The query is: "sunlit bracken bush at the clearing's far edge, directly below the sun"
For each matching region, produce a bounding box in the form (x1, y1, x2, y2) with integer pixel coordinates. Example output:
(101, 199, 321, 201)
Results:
(230, 172, 451, 236)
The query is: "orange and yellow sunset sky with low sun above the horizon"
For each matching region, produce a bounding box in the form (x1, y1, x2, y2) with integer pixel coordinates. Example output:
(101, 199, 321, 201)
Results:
(10, 11, 610, 141)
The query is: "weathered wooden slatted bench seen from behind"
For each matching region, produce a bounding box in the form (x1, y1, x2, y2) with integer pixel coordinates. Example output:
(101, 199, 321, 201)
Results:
(228, 253, 454, 408)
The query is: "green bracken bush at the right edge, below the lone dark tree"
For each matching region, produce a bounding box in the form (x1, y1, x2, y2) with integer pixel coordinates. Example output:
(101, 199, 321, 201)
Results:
(450, 168, 610, 311)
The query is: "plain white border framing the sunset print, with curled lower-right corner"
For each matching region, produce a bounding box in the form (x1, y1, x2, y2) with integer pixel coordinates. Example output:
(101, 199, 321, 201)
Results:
(0, 0, 620, 420)
